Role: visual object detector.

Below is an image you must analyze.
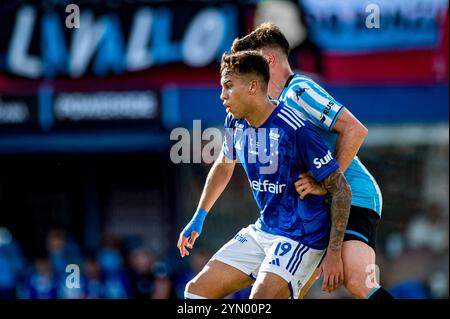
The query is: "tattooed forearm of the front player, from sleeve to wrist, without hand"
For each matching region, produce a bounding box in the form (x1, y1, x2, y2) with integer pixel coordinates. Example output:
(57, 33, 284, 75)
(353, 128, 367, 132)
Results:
(321, 169, 352, 251)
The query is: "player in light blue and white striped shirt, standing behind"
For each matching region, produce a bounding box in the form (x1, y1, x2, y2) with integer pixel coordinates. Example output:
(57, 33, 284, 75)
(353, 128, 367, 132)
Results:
(232, 23, 393, 299)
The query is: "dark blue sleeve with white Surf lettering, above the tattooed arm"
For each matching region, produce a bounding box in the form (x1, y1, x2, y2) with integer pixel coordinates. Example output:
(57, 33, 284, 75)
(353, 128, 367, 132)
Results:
(296, 124, 339, 182)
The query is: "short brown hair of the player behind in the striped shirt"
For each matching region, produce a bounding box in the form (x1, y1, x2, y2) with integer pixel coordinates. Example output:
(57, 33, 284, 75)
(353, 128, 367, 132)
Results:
(231, 22, 290, 56)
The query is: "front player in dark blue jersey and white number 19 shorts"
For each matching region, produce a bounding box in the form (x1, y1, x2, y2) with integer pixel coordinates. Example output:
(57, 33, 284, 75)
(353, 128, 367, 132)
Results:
(177, 51, 351, 299)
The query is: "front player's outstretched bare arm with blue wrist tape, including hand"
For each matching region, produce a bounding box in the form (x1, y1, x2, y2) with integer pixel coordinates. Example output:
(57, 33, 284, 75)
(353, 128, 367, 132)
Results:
(177, 152, 236, 257)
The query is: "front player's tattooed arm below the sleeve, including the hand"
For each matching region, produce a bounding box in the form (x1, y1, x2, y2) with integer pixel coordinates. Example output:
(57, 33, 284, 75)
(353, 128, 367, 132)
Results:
(314, 169, 352, 292)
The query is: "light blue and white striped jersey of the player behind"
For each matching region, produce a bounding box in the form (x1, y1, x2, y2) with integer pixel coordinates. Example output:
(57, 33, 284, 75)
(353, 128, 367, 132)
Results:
(279, 74, 383, 215)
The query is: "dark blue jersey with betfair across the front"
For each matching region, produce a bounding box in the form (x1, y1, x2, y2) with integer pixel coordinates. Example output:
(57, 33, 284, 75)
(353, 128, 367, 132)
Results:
(223, 103, 339, 249)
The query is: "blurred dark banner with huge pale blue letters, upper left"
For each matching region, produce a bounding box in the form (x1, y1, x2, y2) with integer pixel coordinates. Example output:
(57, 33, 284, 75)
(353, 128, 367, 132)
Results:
(0, 1, 245, 79)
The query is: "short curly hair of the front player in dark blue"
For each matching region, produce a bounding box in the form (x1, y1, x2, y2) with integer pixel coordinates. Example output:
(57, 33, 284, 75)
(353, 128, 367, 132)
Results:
(220, 51, 270, 84)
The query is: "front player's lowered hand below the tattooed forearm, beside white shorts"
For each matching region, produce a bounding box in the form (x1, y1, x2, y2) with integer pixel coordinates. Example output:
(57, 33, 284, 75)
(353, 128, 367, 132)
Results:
(316, 250, 344, 293)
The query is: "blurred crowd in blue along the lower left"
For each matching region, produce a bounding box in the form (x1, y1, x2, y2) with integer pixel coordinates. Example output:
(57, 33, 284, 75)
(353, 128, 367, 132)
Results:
(0, 228, 182, 299)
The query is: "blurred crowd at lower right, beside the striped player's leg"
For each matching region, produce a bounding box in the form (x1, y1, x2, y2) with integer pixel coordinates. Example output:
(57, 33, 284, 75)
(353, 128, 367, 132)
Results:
(384, 203, 449, 299)
